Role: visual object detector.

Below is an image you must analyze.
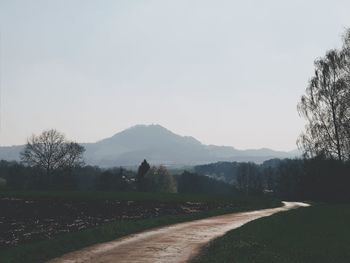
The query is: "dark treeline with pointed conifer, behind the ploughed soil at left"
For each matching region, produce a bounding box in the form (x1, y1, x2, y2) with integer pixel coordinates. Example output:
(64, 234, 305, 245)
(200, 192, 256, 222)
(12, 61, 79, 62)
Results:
(0, 160, 235, 193)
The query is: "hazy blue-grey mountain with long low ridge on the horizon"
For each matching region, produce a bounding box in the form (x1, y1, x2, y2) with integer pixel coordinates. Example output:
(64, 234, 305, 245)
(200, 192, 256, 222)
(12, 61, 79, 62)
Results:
(0, 125, 295, 167)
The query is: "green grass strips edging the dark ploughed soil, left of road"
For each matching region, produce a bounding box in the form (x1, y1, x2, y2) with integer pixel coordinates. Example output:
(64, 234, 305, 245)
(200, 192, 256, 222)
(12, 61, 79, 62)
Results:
(0, 192, 280, 263)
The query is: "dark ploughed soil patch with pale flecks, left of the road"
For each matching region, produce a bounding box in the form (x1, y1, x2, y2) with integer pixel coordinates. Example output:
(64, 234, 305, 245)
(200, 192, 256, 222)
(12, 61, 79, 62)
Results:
(0, 198, 229, 248)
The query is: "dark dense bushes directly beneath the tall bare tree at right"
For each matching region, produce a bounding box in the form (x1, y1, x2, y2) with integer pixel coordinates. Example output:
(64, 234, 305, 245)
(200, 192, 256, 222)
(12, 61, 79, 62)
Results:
(272, 157, 350, 202)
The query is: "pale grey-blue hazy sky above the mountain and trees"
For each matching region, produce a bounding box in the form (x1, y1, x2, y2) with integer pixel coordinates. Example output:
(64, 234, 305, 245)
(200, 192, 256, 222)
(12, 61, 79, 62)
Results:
(0, 0, 350, 150)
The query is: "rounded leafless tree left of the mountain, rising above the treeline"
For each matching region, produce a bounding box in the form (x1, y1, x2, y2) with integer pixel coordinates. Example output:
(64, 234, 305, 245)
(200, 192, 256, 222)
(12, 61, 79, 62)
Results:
(21, 129, 85, 175)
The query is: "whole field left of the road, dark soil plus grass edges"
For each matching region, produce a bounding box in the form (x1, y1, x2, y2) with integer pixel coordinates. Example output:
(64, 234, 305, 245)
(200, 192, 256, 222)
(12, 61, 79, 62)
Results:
(0, 192, 280, 263)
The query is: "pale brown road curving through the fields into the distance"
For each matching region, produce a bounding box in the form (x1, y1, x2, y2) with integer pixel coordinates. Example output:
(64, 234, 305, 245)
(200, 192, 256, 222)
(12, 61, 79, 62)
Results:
(49, 202, 308, 263)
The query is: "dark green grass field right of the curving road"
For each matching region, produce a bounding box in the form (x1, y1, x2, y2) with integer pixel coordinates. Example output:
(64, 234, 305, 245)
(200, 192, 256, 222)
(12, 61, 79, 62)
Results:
(193, 204, 350, 263)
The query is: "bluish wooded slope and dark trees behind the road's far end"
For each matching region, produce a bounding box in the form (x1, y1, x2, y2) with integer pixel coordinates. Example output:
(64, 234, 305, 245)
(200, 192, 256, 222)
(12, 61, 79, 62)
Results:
(195, 157, 350, 202)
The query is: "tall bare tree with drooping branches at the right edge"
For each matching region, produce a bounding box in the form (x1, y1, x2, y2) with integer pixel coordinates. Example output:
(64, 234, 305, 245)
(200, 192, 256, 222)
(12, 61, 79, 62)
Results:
(298, 29, 350, 160)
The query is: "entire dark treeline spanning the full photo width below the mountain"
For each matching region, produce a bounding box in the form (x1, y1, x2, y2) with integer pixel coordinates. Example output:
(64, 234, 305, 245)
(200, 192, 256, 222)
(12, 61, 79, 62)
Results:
(0, 158, 350, 201)
